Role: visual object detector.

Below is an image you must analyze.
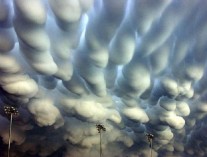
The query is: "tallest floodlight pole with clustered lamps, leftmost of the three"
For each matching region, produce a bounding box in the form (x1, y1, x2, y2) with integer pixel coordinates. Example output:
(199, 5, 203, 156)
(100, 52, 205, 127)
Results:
(4, 106, 19, 157)
